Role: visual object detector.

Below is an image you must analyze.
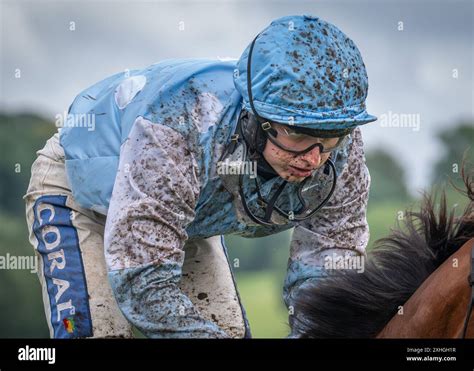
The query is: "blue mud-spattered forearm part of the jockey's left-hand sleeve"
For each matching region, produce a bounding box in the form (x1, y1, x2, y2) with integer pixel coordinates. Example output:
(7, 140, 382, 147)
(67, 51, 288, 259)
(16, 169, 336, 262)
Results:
(109, 263, 228, 338)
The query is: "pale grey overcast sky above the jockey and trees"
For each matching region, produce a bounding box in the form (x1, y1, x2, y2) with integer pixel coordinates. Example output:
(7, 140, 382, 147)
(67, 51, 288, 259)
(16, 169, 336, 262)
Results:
(0, 0, 474, 193)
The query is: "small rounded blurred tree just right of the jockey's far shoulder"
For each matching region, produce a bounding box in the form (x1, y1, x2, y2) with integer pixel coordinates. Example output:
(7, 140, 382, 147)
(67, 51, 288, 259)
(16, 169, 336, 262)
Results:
(366, 149, 410, 203)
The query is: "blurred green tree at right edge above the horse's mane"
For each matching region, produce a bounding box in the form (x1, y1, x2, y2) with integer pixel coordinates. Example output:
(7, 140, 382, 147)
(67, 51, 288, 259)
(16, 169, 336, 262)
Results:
(432, 122, 474, 184)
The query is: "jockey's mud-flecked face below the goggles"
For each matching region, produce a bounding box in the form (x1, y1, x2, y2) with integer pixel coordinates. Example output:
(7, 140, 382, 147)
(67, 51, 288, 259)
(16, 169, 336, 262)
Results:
(263, 136, 330, 183)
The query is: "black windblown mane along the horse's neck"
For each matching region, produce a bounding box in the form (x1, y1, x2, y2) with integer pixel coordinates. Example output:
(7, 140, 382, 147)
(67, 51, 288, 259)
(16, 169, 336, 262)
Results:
(292, 166, 474, 338)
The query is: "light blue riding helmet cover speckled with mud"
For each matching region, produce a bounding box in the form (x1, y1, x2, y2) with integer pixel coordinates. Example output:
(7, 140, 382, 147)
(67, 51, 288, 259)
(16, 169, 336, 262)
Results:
(234, 15, 377, 131)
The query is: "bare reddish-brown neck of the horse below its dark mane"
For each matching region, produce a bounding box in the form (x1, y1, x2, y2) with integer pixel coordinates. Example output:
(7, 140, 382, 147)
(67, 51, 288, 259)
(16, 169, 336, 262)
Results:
(377, 239, 474, 338)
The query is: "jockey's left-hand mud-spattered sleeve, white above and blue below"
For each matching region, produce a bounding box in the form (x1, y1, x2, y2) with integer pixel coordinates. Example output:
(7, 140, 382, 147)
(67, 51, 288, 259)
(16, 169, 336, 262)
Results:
(104, 118, 227, 338)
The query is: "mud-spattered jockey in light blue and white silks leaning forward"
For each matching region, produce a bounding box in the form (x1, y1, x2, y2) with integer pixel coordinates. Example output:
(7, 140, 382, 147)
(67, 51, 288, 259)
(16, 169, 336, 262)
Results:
(25, 15, 376, 338)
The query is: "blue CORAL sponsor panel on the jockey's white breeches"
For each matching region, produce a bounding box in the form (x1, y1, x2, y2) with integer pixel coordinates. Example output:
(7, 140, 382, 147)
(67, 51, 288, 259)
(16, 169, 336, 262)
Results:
(33, 196, 92, 338)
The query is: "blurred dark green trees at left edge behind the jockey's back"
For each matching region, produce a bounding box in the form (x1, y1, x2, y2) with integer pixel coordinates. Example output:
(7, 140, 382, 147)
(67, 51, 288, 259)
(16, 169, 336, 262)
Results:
(0, 113, 56, 338)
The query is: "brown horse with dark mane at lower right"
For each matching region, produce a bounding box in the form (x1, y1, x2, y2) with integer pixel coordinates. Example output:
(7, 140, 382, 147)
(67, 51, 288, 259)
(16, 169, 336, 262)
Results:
(292, 166, 474, 338)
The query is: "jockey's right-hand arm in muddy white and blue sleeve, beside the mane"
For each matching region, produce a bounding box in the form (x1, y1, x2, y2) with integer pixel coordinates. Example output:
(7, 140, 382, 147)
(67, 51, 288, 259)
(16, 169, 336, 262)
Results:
(283, 128, 370, 334)
